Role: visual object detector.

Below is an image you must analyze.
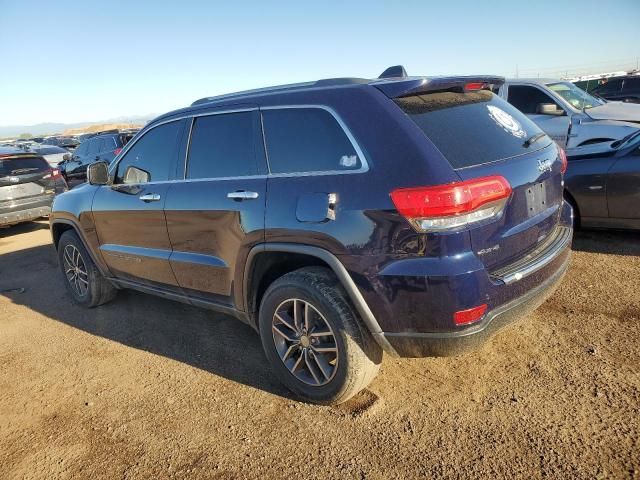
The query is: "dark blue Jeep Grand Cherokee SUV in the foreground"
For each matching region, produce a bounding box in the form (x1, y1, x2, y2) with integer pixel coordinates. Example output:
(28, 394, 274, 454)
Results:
(51, 69, 572, 404)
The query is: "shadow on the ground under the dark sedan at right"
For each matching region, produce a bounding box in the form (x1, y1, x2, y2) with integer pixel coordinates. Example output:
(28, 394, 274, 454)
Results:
(572, 230, 640, 256)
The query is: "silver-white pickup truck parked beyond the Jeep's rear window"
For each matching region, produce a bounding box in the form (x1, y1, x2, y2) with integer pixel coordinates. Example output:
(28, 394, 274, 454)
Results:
(497, 78, 640, 148)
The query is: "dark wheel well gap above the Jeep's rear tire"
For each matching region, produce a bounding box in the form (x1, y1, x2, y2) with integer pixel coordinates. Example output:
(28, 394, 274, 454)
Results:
(247, 252, 333, 327)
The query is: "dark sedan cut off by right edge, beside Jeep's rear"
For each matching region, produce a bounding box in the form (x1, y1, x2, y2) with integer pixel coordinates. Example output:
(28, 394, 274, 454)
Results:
(565, 131, 640, 229)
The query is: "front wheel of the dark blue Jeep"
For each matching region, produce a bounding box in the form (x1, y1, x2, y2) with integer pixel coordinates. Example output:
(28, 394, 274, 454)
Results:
(58, 230, 118, 308)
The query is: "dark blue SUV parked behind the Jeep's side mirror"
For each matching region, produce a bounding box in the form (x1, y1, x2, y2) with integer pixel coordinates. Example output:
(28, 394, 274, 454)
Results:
(60, 132, 135, 188)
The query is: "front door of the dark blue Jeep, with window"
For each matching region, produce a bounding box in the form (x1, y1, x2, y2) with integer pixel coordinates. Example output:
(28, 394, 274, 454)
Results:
(92, 120, 185, 290)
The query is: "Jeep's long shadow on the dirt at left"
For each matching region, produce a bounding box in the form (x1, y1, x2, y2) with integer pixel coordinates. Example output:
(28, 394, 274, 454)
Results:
(0, 245, 293, 398)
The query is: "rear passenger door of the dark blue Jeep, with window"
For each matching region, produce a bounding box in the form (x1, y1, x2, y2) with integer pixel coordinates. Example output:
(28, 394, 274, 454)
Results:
(164, 108, 266, 309)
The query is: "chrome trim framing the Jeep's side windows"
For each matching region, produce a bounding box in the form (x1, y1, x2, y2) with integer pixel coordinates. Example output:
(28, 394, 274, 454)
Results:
(109, 104, 369, 185)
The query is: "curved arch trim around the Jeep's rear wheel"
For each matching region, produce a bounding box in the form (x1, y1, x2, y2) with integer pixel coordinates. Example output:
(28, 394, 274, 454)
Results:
(242, 243, 397, 356)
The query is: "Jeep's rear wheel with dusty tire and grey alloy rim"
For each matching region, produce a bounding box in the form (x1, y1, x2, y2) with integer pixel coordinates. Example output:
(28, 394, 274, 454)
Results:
(259, 267, 382, 405)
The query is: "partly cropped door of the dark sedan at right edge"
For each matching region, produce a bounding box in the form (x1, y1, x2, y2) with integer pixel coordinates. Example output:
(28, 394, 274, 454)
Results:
(607, 146, 640, 220)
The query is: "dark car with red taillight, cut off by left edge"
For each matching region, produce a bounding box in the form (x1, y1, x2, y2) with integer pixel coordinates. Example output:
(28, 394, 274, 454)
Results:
(0, 147, 67, 226)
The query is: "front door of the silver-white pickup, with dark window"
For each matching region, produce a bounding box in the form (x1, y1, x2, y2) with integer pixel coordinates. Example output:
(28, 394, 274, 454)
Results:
(507, 84, 571, 148)
